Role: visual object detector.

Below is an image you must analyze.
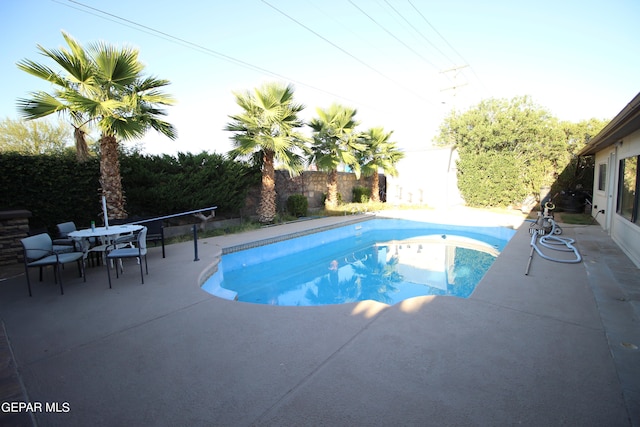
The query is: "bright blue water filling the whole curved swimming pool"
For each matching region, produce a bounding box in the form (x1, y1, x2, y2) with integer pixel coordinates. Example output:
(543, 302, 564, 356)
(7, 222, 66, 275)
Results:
(202, 219, 515, 306)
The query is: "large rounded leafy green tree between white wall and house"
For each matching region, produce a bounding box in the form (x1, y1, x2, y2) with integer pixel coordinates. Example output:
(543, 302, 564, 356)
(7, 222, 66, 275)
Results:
(437, 96, 569, 206)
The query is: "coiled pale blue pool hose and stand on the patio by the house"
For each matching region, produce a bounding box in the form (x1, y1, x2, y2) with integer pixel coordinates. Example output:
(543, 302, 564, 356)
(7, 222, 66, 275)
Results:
(524, 201, 582, 276)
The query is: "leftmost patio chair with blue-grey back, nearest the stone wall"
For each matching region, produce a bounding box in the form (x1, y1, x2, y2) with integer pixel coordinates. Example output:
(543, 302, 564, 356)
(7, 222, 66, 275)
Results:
(20, 233, 87, 296)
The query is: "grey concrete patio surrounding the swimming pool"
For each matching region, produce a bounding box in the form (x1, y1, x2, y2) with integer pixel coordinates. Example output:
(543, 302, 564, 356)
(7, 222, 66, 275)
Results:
(0, 210, 640, 426)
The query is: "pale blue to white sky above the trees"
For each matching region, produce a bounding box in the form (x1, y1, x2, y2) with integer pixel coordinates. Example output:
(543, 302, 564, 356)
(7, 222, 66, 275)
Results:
(0, 0, 640, 155)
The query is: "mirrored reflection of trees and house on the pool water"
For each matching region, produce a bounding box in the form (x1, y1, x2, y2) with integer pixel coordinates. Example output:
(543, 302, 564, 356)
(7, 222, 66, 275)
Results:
(228, 235, 498, 305)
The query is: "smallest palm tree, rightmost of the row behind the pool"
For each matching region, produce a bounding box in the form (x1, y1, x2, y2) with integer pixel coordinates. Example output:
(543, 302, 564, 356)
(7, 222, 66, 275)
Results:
(360, 127, 404, 202)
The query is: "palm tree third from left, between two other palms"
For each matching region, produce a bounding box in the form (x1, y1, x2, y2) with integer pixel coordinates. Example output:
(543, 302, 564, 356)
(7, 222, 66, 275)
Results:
(309, 104, 365, 209)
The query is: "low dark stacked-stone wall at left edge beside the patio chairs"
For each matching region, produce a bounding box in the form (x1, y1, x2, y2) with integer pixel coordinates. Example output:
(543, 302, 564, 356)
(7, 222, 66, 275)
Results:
(0, 210, 31, 266)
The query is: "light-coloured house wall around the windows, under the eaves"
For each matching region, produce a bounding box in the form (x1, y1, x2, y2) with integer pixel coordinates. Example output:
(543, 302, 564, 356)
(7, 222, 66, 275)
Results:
(592, 127, 640, 267)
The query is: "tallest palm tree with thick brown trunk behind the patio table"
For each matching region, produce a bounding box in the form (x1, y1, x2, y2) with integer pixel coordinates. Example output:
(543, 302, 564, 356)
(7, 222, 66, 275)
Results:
(17, 32, 177, 219)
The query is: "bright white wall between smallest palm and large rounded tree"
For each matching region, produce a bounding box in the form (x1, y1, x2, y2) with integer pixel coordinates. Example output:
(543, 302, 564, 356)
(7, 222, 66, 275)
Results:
(387, 147, 463, 207)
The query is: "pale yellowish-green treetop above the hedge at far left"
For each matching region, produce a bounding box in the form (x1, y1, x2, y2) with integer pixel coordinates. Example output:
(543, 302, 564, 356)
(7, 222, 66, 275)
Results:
(0, 119, 72, 155)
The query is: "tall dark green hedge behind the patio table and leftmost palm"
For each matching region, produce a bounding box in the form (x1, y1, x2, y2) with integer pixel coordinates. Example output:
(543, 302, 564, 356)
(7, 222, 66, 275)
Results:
(0, 153, 260, 233)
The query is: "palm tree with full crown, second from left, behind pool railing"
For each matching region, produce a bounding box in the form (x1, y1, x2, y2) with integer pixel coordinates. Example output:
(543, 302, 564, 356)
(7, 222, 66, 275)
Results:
(225, 83, 308, 223)
